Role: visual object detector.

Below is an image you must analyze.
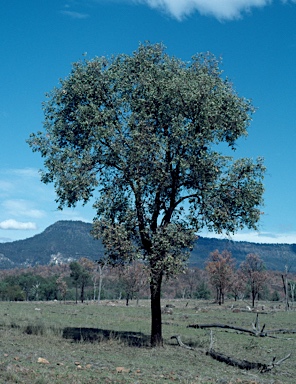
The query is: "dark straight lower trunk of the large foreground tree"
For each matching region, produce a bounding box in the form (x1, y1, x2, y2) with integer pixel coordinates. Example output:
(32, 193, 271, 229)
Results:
(150, 270, 163, 347)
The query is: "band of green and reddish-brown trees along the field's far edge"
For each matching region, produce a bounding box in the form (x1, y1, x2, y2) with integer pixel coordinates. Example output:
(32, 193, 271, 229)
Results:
(0, 254, 296, 306)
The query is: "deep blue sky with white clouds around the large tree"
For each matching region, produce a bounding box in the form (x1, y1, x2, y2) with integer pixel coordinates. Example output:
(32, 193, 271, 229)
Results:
(0, 0, 296, 243)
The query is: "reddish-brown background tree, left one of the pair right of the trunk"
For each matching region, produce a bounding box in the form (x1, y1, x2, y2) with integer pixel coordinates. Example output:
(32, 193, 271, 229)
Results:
(206, 250, 235, 305)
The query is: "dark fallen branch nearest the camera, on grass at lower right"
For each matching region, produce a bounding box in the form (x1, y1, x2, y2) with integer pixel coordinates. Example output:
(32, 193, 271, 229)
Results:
(171, 335, 291, 373)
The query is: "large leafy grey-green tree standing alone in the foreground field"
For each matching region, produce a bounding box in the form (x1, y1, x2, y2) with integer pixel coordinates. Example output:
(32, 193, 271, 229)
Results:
(28, 43, 264, 346)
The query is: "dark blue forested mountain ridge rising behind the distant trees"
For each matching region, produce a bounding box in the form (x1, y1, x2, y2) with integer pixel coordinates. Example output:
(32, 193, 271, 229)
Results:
(0, 221, 296, 270)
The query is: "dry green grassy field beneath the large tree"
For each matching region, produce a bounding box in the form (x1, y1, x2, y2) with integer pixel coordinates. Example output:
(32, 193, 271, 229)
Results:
(0, 300, 296, 384)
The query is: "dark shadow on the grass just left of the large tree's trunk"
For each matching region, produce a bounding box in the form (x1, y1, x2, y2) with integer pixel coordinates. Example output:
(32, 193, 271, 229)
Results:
(63, 327, 150, 347)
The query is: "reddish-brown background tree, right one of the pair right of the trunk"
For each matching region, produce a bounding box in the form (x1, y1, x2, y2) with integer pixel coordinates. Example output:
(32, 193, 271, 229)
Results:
(240, 253, 267, 307)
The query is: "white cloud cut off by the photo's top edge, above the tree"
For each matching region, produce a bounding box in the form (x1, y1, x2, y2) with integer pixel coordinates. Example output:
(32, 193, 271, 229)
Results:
(134, 0, 272, 20)
